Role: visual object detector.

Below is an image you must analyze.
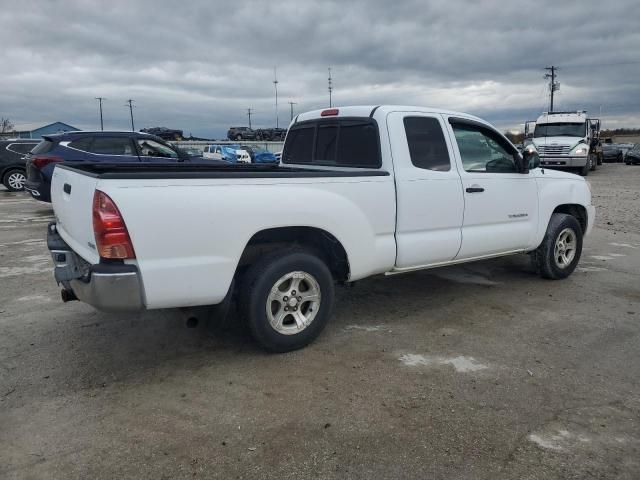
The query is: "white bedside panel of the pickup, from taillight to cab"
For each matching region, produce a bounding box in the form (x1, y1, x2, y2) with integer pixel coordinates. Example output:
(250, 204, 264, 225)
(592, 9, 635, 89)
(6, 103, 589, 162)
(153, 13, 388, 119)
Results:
(97, 176, 396, 308)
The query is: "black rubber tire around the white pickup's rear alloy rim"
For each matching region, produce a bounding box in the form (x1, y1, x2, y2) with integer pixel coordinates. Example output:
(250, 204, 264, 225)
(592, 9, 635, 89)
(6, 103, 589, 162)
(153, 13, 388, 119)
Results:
(238, 250, 335, 352)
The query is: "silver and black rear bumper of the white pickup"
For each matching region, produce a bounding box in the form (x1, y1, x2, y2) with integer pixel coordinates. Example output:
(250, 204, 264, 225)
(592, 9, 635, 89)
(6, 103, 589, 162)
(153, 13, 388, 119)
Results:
(47, 223, 144, 312)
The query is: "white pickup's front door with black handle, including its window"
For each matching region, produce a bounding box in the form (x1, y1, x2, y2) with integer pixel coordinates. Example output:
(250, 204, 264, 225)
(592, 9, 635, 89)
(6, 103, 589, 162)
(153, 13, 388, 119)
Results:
(448, 118, 538, 259)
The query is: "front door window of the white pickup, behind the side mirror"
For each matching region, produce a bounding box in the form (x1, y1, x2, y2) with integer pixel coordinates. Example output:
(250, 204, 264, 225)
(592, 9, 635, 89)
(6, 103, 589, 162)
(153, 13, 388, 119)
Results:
(452, 123, 518, 173)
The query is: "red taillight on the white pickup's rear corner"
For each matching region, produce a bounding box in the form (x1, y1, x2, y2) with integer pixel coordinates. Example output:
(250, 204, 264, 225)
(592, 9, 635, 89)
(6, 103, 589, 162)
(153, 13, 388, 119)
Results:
(93, 190, 136, 259)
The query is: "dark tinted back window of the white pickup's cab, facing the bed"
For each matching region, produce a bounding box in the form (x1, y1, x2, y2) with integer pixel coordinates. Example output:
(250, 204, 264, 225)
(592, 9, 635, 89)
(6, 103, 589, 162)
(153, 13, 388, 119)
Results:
(282, 117, 382, 168)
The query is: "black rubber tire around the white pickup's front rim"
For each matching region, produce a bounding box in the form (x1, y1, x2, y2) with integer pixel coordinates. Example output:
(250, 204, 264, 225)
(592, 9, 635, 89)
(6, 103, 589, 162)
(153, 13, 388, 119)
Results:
(532, 213, 583, 280)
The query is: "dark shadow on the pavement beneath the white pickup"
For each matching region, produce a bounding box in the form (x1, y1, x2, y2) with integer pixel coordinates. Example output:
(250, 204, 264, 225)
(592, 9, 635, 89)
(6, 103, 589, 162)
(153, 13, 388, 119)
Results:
(27, 256, 539, 388)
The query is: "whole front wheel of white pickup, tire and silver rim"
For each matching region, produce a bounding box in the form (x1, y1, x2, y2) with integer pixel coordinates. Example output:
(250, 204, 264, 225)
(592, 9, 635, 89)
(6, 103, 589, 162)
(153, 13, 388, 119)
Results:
(532, 213, 582, 280)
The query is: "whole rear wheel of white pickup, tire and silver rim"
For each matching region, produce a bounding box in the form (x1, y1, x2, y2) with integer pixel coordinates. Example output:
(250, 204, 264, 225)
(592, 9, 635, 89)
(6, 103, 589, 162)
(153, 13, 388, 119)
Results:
(238, 250, 334, 352)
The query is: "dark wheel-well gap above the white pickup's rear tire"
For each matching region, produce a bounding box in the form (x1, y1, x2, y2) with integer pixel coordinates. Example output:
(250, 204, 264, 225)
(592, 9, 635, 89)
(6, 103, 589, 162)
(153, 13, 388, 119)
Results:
(236, 227, 350, 281)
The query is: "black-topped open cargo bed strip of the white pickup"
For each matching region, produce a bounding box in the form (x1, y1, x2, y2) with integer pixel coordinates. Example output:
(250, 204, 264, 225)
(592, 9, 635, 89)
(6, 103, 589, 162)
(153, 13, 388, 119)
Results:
(56, 162, 389, 180)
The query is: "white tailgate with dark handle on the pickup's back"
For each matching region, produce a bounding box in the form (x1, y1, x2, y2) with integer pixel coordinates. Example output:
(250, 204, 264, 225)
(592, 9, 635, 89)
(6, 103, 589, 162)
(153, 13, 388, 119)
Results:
(51, 166, 100, 263)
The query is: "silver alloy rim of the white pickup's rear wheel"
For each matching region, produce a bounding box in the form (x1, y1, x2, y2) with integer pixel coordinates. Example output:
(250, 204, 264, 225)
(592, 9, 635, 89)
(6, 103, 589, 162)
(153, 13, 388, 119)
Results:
(266, 271, 322, 335)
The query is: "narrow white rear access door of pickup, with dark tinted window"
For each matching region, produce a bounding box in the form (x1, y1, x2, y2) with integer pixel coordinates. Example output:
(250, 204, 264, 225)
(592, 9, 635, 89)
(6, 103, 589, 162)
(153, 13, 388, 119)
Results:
(387, 112, 464, 270)
